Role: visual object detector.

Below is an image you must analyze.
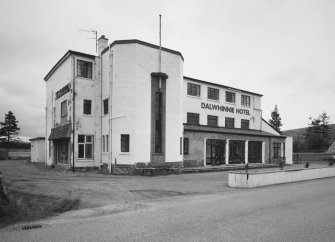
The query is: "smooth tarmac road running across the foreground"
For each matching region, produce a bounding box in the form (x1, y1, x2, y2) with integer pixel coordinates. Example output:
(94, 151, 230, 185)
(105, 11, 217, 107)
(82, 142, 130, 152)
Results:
(0, 178, 335, 241)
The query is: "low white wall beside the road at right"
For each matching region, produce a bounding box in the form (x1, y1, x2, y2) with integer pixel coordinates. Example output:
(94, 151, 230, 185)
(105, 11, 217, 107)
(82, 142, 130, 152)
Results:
(228, 167, 335, 188)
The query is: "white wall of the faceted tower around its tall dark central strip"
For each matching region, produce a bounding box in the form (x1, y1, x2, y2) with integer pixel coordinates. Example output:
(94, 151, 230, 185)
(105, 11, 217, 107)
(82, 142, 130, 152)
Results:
(110, 44, 183, 164)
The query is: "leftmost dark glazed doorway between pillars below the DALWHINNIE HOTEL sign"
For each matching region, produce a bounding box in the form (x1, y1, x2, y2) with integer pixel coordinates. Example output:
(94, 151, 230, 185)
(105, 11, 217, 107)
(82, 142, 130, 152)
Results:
(206, 139, 226, 166)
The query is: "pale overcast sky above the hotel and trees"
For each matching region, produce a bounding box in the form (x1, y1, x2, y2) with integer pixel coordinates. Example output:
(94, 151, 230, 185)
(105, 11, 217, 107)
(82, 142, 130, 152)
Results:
(0, 0, 335, 137)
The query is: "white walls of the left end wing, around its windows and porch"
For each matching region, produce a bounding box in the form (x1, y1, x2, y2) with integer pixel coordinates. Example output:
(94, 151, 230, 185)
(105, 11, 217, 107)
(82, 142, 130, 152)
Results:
(46, 56, 101, 167)
